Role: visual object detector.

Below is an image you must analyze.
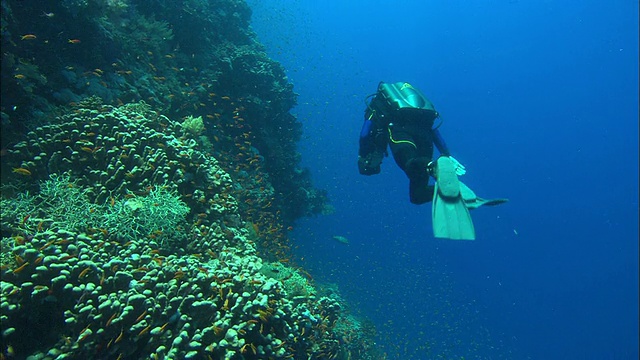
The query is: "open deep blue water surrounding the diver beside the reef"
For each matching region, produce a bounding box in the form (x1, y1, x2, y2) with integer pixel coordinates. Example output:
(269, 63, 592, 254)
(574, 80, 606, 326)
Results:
(250, 0, 638, 359)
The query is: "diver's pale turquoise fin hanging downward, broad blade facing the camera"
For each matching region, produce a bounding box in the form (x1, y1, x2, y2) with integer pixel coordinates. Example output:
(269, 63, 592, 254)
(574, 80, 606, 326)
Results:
(431, 156, 476, 240)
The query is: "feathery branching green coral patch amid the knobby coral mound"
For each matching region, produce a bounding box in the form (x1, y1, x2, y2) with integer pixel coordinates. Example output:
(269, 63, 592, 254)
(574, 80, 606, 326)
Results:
(1, 173, 189, 246)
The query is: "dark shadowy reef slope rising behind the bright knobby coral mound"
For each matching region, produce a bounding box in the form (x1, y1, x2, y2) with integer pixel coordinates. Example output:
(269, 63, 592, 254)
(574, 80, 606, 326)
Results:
(0, 0, 328, 231)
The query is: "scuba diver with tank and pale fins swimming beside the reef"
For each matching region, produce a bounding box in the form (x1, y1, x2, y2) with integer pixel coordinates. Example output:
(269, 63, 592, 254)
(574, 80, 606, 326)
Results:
(358, 82, 508, 240)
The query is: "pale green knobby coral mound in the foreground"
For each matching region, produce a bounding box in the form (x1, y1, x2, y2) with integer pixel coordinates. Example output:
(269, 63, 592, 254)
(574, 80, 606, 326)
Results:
(0, 99, 380, 359)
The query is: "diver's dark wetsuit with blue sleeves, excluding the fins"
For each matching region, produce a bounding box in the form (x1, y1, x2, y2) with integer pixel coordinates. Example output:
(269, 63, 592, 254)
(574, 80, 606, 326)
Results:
(358, 83, 449, 204)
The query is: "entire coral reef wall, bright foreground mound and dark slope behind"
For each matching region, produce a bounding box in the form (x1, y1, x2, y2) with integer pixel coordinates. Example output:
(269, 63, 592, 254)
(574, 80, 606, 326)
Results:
(0, 0, 379, 359)
